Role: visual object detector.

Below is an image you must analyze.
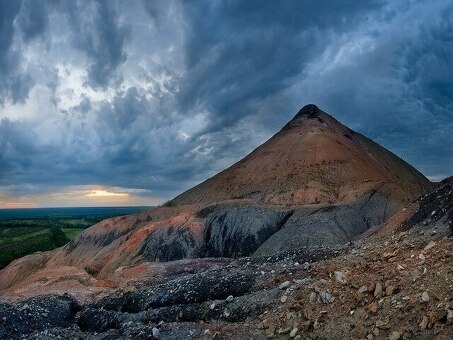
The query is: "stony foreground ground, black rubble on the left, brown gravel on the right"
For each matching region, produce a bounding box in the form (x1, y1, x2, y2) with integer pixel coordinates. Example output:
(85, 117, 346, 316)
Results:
(0, 181, 453, 339)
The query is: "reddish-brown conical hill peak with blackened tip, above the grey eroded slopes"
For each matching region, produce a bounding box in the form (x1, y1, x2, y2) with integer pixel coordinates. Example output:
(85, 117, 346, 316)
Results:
(173, 104, 430, 205)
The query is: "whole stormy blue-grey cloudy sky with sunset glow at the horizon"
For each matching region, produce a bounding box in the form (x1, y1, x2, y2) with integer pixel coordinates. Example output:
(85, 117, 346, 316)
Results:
(0, 0, 453, 207)
